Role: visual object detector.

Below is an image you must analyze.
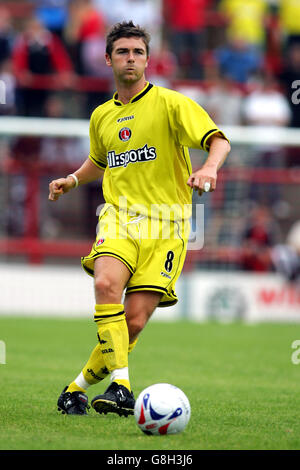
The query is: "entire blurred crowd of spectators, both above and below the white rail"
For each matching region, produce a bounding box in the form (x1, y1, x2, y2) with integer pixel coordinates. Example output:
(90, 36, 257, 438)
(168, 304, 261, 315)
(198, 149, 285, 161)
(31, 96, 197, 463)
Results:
(0, 0, 300, 280)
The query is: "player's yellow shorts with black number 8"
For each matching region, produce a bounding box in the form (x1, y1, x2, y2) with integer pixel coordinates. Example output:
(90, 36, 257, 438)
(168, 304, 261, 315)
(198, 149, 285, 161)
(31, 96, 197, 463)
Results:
(81, 204, 190, 307)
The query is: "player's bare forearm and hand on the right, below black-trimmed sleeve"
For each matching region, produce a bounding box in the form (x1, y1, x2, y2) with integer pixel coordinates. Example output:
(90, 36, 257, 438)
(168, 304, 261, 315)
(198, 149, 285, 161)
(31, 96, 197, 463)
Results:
(187, 134, 231, 196)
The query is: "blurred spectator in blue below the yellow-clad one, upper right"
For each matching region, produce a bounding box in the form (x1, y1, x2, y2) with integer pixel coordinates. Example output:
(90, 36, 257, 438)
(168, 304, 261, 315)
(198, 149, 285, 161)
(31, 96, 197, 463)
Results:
(215, 37, 262, 85)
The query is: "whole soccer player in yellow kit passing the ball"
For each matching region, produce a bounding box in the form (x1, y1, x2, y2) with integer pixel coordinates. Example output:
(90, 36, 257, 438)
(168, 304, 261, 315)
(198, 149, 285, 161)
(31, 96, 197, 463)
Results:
(49, 22, 230, 416)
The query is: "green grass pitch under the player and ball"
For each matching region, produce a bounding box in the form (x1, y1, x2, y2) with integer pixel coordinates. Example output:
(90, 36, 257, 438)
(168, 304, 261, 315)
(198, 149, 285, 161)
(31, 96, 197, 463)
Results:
(0, 317, 300, 451)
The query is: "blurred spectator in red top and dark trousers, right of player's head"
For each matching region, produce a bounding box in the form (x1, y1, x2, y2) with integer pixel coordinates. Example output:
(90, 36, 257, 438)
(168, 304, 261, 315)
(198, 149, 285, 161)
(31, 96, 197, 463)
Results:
(164, 0, 211, 79)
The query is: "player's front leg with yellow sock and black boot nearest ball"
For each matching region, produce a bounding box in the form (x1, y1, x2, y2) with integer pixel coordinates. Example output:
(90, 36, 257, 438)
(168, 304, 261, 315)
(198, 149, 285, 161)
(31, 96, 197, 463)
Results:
(91, 257, 139, 416)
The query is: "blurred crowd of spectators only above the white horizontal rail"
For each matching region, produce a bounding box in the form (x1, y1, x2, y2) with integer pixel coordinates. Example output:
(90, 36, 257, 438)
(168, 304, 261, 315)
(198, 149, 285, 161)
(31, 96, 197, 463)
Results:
(0, 0, 300, 127)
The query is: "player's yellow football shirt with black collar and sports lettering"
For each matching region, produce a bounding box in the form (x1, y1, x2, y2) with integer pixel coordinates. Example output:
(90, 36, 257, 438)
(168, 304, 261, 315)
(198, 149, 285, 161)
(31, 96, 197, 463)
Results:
(89, 82, 226, 220)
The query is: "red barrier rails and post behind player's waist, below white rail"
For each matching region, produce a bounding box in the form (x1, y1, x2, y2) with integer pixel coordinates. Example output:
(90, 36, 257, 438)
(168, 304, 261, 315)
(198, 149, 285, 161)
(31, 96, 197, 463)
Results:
(0, 165, 300, 270)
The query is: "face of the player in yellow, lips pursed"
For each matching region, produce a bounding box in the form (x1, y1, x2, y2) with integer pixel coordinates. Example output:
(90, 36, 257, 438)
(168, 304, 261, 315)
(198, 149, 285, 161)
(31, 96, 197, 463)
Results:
(105, 37, 148, 83)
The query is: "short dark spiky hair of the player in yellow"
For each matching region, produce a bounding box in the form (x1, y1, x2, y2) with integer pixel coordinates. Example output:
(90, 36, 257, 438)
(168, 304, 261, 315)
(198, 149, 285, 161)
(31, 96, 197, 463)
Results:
(106, 21, 150, 57)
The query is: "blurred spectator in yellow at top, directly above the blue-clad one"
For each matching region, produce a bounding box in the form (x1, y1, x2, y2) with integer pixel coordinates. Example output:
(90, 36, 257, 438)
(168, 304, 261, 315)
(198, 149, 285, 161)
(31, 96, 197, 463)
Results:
(219, 0, 268, 49)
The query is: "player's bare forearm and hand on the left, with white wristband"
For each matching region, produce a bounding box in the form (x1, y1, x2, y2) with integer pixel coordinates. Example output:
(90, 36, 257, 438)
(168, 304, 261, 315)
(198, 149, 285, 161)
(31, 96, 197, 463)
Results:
(48, 158, 104, 201)
